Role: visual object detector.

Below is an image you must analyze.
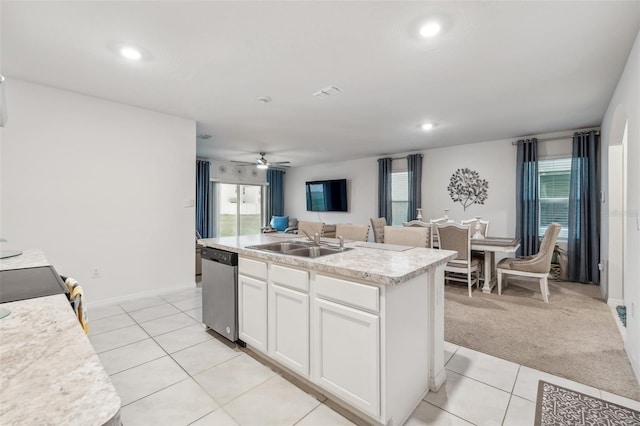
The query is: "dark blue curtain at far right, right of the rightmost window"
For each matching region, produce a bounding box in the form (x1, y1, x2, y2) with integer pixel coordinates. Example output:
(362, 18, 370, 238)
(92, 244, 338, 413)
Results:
(567, 131, 600, 284)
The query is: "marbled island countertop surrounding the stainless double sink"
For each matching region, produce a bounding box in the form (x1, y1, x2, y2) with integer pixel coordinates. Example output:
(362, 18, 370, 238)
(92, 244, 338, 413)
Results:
(199, 234, 456, 285)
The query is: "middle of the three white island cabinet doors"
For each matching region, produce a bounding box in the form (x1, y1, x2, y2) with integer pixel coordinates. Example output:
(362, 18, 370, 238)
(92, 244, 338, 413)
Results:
(269, 284, 309, 377)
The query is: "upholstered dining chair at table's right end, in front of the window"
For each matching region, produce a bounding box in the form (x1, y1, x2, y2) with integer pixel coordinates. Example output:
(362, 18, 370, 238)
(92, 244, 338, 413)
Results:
(496, 222, 562, 303)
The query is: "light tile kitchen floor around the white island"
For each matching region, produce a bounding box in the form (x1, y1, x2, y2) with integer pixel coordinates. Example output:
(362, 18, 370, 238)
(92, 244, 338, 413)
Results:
(89, 288, 640, 426)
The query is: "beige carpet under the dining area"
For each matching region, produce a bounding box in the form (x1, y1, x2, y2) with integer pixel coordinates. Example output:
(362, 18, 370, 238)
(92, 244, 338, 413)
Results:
(444, 279, 640, 401)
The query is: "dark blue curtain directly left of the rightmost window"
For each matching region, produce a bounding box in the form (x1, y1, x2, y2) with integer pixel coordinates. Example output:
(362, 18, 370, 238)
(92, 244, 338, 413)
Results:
(516, 138, 540, 256)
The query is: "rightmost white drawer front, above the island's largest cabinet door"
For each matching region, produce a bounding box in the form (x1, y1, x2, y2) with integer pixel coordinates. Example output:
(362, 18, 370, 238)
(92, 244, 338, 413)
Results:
(315, 275, 380, 312)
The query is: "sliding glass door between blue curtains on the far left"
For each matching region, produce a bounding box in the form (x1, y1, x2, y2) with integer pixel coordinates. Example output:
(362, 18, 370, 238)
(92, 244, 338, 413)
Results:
(211, 183, 264, 237)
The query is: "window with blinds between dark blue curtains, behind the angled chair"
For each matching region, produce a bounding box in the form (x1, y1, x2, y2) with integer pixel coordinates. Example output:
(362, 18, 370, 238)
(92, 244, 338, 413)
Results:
(538, 158, 571, 239)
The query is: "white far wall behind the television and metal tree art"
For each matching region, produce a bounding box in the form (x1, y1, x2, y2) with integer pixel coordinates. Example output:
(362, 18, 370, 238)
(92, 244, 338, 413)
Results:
(285, 132, 571, 240)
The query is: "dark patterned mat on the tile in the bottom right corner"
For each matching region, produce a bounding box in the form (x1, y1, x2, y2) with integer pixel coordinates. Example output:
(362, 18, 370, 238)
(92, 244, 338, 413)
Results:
(534, 380, 640, 426)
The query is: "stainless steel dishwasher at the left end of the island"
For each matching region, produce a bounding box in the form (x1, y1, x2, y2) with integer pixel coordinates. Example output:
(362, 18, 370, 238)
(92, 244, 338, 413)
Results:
(202, 247, 238, 342)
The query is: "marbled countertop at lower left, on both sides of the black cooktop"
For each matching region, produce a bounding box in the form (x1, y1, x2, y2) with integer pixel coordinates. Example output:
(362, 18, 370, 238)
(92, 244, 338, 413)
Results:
(0, 250, 121, 426)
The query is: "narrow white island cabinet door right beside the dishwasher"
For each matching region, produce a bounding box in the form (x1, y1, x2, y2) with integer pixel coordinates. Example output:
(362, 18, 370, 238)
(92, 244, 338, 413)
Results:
(238, 275, 267, 352)
